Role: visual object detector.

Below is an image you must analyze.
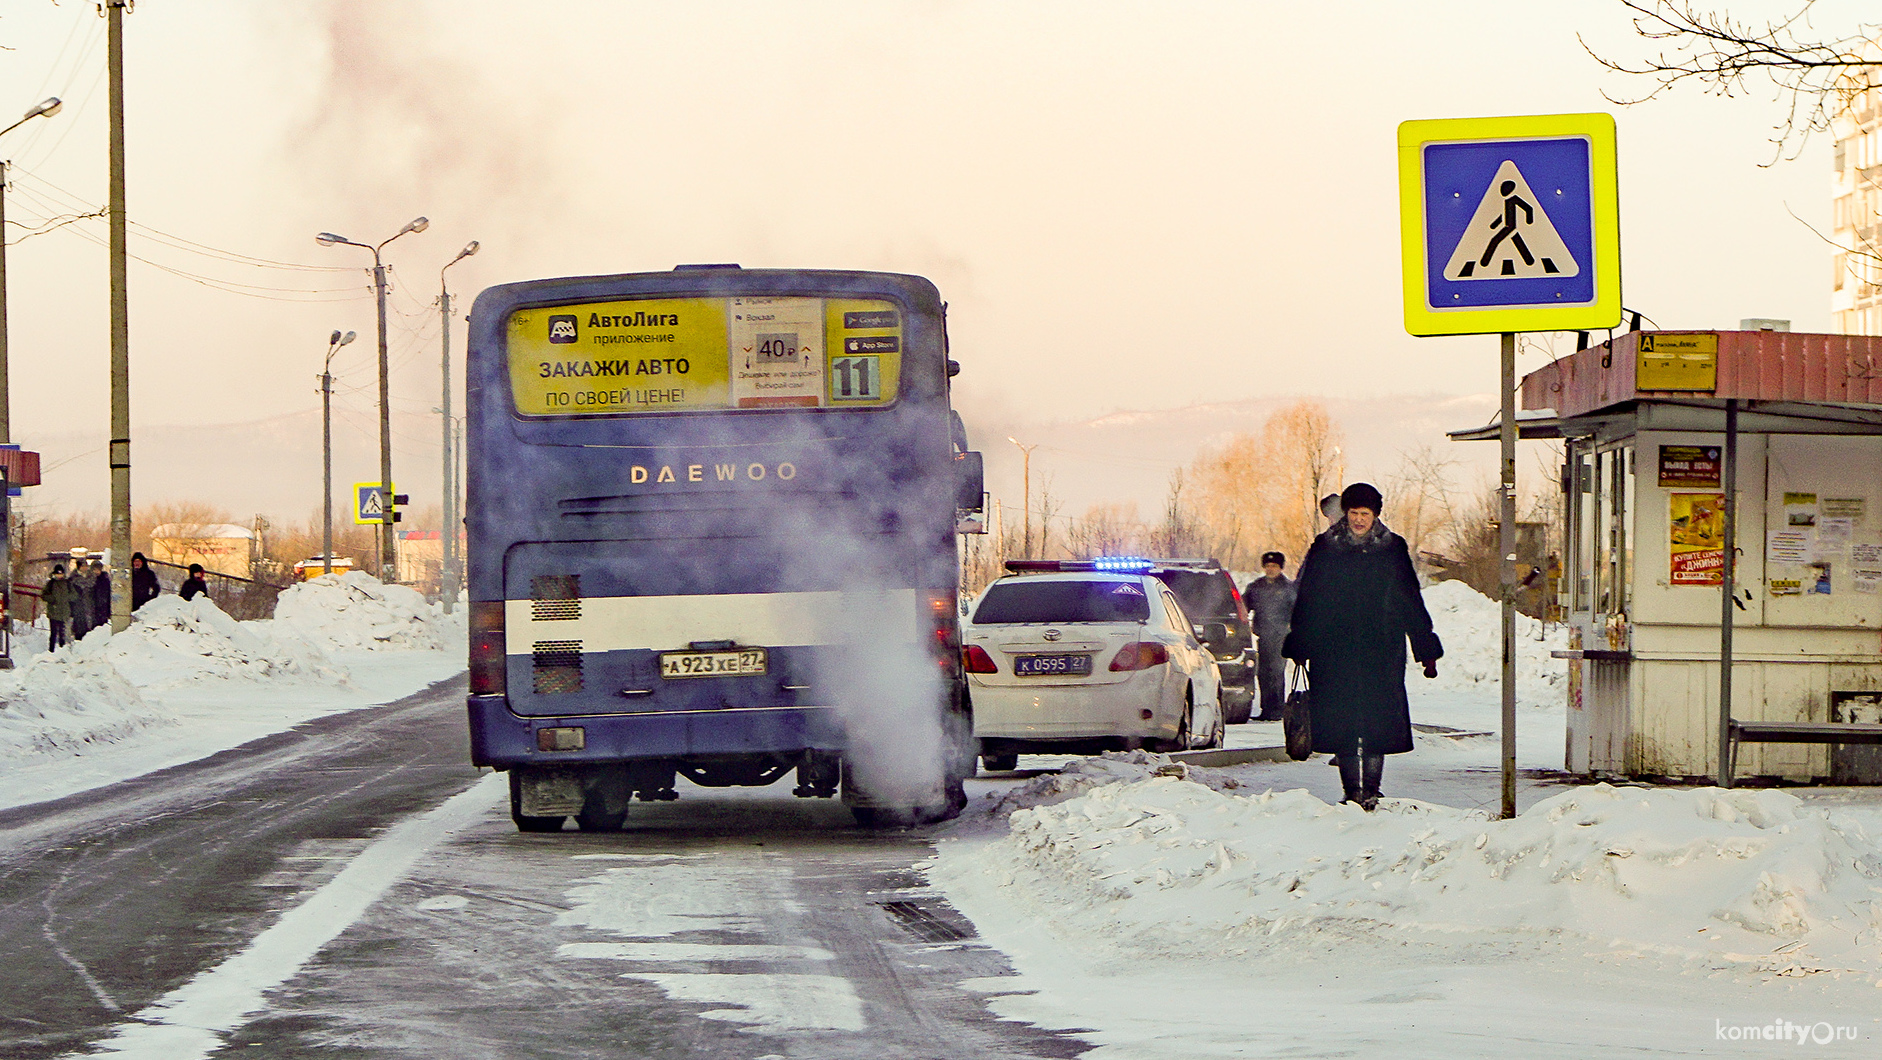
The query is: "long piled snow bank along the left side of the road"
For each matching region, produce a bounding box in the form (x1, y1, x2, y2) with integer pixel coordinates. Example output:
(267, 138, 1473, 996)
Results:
(0, 572, 465, 808)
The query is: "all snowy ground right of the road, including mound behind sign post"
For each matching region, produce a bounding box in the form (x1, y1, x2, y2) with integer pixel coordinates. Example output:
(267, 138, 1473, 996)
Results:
(930, 586, 1882, 1060)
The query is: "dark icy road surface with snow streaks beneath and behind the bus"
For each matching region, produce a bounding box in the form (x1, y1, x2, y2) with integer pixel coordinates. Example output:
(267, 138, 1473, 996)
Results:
(0, 680, 1086, 1060)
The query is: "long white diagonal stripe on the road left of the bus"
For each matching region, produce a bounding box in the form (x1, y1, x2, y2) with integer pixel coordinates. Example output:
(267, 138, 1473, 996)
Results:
(70, 774, 508, 1060)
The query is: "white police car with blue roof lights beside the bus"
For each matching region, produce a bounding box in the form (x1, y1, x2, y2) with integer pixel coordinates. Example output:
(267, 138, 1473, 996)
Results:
(962, 559, 1223, 770)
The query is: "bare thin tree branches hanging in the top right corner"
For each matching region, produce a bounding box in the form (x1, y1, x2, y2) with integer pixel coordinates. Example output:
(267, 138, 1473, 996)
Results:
(1581, 0, 1882, 158)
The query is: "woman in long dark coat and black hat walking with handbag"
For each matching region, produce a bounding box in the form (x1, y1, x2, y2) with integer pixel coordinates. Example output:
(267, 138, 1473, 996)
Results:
(1285, 482, 1443, 811)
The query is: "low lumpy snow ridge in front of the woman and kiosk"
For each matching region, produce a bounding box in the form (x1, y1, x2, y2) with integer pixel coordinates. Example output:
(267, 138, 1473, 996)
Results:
(932, 779, 1882, 973)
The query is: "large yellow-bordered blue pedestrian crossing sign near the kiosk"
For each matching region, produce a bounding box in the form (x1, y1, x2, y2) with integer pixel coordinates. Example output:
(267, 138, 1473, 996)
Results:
(1398, 115, 1620, 335)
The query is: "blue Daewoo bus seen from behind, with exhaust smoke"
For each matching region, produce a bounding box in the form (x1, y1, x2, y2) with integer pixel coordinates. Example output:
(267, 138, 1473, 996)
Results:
(465, 265, 981, 832)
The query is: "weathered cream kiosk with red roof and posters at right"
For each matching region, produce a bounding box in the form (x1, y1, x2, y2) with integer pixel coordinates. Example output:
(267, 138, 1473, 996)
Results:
(1453, 331, 1882, 783)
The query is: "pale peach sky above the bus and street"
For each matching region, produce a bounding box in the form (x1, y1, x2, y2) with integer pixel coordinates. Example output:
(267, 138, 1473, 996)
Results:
(0, 0, 1861, 516)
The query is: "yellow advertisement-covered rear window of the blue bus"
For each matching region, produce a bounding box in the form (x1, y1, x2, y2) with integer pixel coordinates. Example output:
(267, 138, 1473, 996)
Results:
(506, 296, 907, 416)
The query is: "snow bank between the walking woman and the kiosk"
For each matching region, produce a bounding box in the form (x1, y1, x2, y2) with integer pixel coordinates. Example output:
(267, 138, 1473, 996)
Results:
(1406, 582, 1568, 710)
